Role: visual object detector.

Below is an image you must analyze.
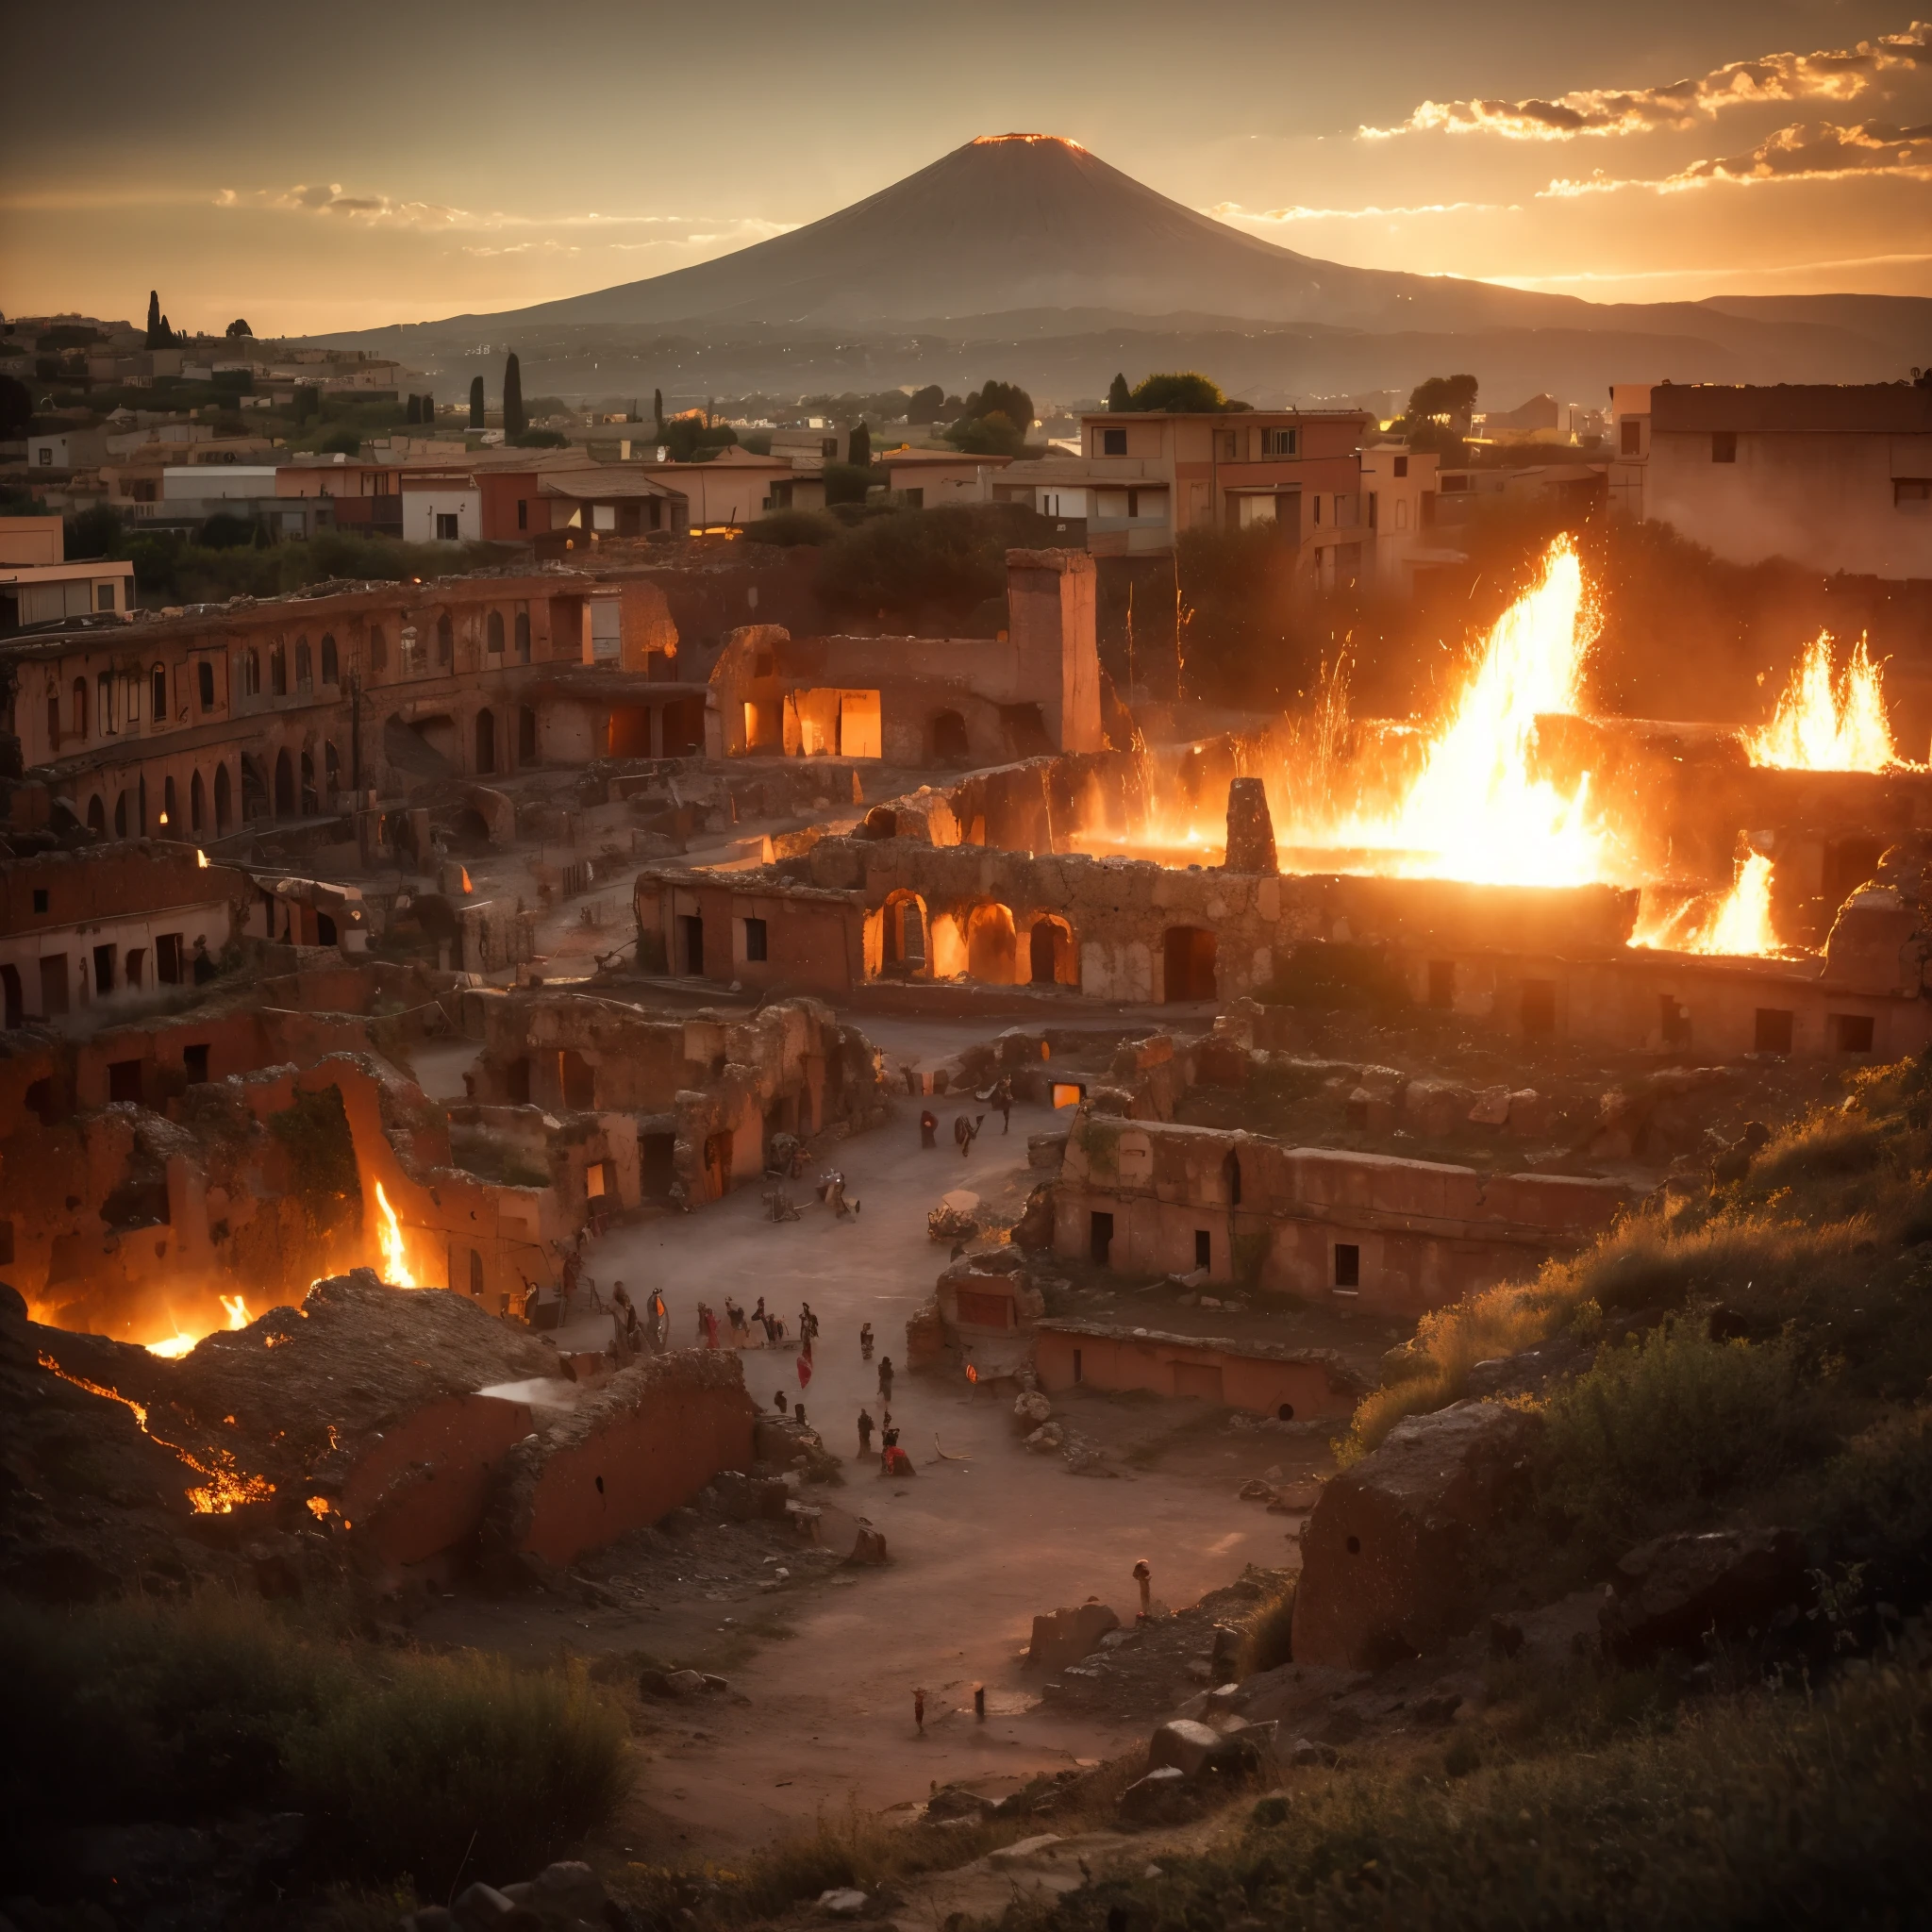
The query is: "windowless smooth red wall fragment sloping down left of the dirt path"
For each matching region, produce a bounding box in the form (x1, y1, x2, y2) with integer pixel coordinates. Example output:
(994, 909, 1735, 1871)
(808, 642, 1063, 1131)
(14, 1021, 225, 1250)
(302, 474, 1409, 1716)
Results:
(487, 1349, 758, 1565)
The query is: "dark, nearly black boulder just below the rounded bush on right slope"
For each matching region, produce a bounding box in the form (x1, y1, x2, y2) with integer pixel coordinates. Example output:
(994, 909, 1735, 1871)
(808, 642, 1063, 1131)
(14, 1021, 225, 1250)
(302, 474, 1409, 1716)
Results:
(1600, 1528, 1805, 1659)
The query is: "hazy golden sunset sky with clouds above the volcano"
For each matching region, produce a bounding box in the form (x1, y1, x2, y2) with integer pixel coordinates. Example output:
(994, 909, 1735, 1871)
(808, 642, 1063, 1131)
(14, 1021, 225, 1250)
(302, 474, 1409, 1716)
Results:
(0, 0, 1932, 336)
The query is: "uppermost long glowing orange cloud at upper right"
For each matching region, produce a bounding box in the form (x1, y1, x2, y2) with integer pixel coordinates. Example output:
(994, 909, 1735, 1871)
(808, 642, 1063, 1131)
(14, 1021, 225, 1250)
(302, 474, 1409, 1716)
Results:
(1358, 19, 1932, 142)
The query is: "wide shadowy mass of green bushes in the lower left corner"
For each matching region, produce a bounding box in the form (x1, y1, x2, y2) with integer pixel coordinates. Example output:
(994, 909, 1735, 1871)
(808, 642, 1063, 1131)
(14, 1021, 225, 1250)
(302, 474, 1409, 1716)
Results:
(0, 1596, 625, 1895)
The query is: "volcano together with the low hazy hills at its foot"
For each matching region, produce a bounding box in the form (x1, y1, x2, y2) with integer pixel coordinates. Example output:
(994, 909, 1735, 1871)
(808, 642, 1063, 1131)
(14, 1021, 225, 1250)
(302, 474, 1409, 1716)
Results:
(326, 133, 1932, 406)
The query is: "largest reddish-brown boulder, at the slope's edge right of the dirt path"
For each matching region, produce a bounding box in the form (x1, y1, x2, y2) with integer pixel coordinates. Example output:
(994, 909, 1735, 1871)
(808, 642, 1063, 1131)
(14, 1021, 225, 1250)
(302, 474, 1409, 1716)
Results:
(1294, 1403, 1541, 1669)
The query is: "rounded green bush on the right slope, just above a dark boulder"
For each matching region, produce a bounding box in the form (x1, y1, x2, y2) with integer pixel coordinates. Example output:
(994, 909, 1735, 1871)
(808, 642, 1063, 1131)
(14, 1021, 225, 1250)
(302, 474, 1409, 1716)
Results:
(1540, 1327, 1829, 1547)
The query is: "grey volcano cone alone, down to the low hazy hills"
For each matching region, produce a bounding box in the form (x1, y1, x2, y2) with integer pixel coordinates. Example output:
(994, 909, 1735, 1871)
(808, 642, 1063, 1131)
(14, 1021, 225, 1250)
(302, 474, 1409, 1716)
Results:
(507, 133, 1591, 330)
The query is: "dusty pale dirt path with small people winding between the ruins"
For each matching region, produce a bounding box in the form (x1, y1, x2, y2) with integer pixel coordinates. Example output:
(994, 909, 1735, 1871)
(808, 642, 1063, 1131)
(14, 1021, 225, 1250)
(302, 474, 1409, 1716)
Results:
(424, 1090, 1292, 1853)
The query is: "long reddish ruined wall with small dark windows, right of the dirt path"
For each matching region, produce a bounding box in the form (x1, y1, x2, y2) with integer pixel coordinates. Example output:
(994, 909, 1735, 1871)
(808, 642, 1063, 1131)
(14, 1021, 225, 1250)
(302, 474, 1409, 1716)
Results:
(1053, 1108, 1628, 1316)
